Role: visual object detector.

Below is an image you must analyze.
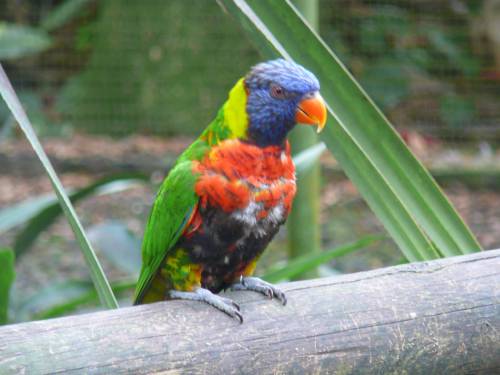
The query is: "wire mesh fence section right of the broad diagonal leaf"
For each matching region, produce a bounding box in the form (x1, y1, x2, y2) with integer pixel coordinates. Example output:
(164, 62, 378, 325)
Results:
(322, 0, 500, 141)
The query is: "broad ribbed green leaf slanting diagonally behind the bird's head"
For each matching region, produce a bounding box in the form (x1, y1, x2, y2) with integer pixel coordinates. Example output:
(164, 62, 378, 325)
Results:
(219, 0, 480, 261)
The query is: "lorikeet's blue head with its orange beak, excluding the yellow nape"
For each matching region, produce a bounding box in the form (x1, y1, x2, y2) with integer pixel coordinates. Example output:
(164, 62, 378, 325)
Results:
(245, 59, 326, 146)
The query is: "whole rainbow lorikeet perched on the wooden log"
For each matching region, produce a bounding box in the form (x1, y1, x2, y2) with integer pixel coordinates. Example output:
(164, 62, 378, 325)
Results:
(134, 59, 326, 322)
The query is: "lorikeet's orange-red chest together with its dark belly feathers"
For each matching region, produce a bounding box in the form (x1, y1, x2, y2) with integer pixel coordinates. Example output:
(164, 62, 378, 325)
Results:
(178, 140, 296, 291)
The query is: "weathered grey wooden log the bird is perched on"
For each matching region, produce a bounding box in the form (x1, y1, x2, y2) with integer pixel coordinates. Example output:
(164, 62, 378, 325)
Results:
(0, 250, 500, 374)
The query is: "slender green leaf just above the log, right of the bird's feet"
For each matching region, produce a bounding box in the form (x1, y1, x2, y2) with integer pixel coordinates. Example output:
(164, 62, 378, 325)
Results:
(263, 235, 384, 283)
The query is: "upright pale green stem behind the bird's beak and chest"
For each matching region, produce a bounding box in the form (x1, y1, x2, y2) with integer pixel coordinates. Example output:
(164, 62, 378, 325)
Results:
(288, 0, 321, 280)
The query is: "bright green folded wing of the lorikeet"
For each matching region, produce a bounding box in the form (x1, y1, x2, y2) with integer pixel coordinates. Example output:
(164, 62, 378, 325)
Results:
(134, 159, 198, 304)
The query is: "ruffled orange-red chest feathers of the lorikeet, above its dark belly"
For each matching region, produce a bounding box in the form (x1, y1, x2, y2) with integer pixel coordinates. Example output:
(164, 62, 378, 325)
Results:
(193, 140, 295, 230)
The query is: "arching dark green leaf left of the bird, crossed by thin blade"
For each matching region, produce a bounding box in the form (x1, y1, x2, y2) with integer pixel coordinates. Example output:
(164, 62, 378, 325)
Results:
(12, 173, 148, 258)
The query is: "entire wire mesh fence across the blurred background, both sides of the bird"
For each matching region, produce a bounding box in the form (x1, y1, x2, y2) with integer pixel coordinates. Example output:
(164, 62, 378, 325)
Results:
(0, 0, 500, 139)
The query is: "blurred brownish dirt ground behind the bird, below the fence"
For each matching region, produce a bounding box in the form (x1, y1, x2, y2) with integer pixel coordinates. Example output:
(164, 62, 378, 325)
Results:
(0, 135, 500, 322)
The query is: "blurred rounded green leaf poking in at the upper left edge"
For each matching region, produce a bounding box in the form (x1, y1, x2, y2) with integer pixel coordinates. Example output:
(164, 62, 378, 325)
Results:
(0, 22, 52, 60)
